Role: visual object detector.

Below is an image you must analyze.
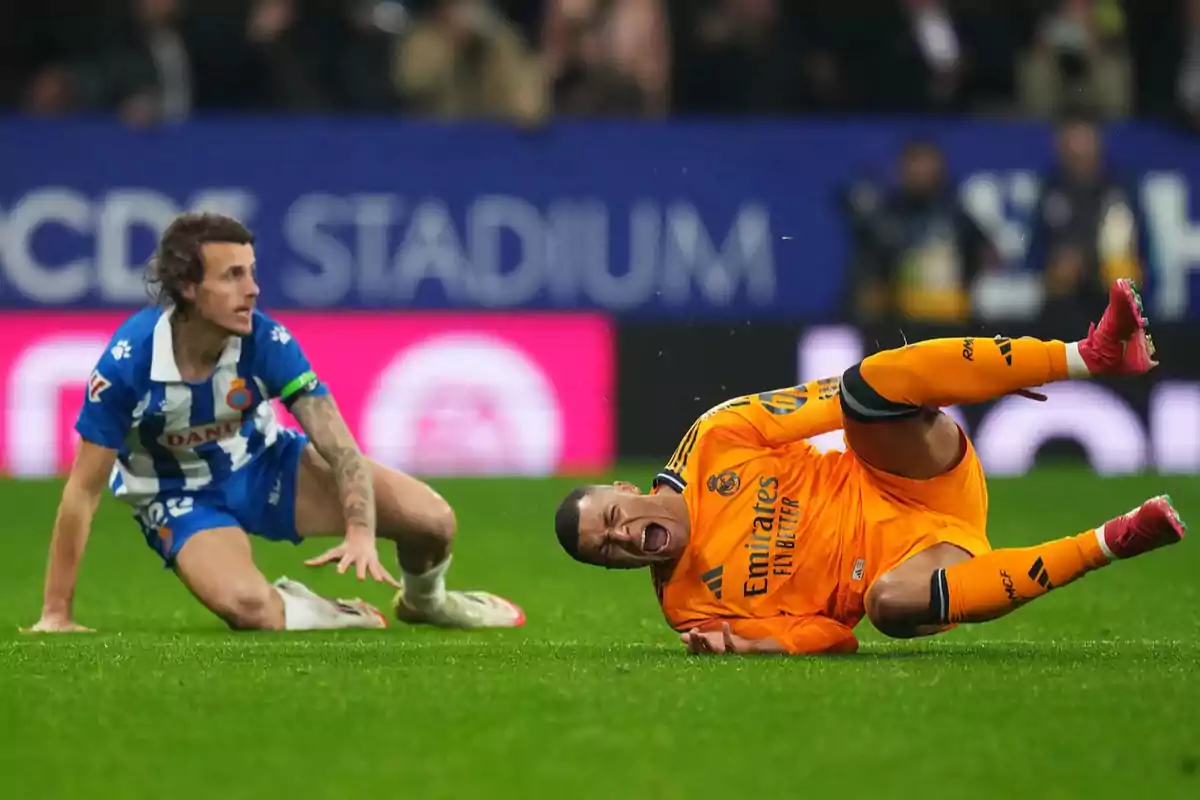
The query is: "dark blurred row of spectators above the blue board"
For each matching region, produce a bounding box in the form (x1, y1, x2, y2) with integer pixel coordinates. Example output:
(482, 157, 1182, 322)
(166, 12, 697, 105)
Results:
(0, 0, 1200, 124)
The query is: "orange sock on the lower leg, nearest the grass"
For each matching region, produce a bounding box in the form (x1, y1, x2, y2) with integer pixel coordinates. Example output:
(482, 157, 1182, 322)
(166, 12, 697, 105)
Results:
(930, 530, 1109, 624)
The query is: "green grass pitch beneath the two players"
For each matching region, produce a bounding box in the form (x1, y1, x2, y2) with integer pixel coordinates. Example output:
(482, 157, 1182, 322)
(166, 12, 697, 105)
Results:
(0, 470, 1200, 800)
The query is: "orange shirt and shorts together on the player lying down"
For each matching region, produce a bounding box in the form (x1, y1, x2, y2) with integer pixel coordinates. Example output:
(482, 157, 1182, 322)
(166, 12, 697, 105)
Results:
(654, 379, 990, 652)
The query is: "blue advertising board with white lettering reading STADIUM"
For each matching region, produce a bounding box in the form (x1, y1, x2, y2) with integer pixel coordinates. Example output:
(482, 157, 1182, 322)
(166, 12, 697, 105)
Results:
(0, 119, 1200, 320)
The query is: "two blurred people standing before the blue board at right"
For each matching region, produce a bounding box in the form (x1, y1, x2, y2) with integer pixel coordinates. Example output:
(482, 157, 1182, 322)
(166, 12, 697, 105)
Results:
(840, 116, 1132, 335)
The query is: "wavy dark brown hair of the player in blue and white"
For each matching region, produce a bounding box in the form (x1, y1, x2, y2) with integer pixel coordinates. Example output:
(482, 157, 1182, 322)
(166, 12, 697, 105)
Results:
(146, 211, 254, 308)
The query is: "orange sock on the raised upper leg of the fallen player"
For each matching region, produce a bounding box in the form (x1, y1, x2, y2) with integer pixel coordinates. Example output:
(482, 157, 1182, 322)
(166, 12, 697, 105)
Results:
(842, 336, 1087, 412)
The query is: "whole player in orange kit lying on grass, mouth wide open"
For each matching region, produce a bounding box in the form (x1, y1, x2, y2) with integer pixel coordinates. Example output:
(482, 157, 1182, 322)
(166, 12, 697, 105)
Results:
(554, 281, 1184, 654)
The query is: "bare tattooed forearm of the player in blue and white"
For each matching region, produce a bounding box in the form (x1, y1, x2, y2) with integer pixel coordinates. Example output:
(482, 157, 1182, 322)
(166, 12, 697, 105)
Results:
(290, 395, 376, 536)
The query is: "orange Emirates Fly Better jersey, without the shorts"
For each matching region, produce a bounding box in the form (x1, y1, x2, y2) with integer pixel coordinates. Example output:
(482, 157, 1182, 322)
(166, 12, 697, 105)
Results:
(655, 380, 864, 651)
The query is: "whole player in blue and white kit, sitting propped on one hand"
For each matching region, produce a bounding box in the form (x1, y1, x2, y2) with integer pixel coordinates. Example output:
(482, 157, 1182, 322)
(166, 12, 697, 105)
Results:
(25, 215, 524, 631)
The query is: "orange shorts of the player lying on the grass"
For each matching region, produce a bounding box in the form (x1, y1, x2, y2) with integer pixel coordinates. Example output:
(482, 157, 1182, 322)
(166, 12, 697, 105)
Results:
(858, 424, 991, 589)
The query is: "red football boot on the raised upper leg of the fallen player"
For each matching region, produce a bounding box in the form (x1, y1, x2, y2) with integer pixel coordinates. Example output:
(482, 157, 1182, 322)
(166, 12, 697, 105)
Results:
(1079, 278, 1158, 375)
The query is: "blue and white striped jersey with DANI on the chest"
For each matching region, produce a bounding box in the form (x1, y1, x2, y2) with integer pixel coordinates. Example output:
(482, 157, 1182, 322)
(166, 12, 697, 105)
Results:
(76, 308, 328, 505)
